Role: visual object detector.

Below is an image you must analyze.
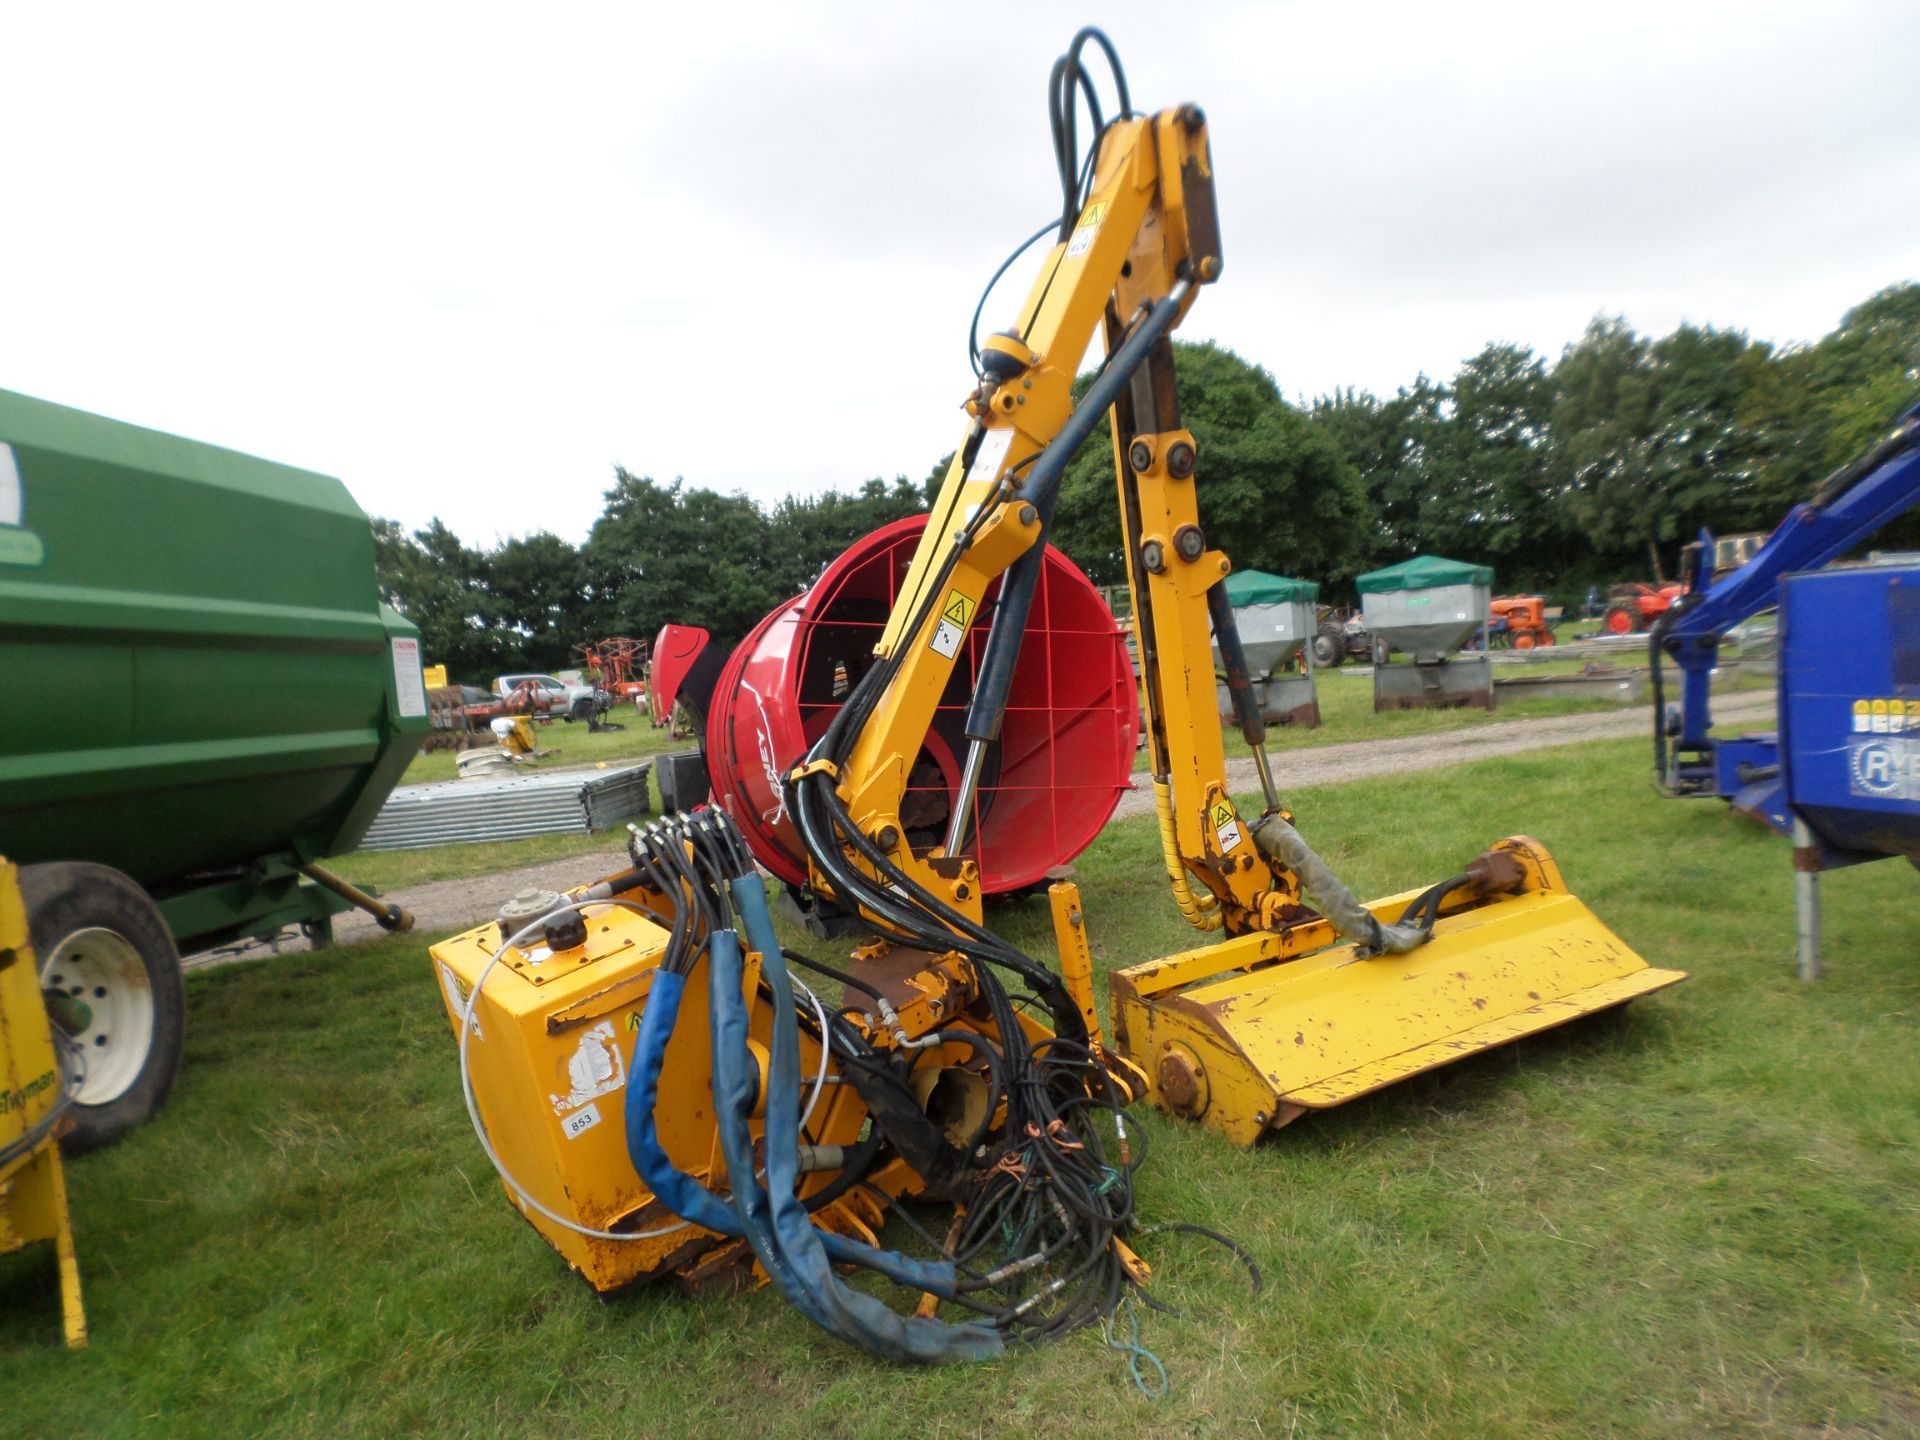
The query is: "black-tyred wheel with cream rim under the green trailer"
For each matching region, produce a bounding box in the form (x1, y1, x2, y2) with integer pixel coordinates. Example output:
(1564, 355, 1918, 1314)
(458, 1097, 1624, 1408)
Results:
(19, 862, 186, 1154)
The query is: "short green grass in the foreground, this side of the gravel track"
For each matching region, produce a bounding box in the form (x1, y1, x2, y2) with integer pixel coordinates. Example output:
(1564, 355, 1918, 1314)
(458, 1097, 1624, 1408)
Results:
(0, 741, 1920, 1438)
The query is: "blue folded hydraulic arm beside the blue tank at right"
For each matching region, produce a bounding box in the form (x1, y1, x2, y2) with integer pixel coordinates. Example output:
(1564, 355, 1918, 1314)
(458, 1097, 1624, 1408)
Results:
(1649, 405, 1920, 824)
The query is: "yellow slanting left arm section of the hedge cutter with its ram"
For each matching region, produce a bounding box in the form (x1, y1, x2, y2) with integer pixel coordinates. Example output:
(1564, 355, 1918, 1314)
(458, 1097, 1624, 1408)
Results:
(814, 106, 1221, 918)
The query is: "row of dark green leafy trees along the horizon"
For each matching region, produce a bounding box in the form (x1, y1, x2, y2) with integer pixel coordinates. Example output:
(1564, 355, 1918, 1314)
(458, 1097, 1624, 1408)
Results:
(374, 284, 1920, 680)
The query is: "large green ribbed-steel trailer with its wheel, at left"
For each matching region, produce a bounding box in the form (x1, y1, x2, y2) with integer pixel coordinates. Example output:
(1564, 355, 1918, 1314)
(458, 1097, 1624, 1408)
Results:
(0, 390, 428, 1144)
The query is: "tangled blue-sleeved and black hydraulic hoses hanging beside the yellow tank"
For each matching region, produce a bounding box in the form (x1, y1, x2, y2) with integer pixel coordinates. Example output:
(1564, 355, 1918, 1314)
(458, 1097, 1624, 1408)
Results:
(626, 814, 1167, 1361)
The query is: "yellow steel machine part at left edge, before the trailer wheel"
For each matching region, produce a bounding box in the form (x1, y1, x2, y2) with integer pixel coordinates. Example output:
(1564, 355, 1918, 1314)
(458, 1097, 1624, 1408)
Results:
(0, 860, 86, 1348)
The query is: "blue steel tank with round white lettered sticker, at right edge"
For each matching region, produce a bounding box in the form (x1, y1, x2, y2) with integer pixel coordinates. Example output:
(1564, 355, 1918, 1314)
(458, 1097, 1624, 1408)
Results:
(1780, 564, 1920, 870)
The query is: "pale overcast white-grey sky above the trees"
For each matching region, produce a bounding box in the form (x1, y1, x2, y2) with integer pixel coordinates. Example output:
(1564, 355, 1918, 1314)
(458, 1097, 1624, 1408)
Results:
(0, 0, 1920, 543)
